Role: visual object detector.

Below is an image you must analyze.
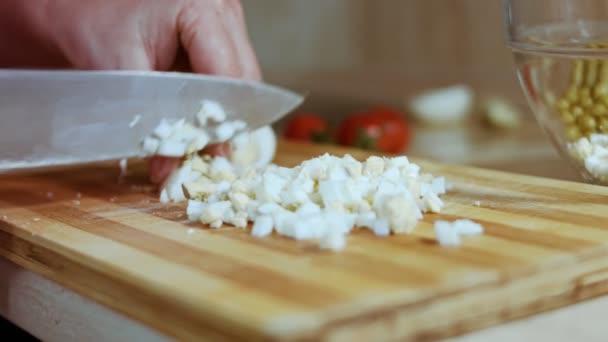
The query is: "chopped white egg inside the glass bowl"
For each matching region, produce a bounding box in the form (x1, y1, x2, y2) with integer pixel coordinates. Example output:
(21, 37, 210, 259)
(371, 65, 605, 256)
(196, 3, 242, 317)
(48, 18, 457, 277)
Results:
(568, 133, 608, 183)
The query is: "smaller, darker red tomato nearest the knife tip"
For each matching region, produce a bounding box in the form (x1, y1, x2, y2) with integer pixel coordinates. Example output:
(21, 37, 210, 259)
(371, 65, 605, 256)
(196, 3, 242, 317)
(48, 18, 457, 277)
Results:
(285, 113, 329, 143)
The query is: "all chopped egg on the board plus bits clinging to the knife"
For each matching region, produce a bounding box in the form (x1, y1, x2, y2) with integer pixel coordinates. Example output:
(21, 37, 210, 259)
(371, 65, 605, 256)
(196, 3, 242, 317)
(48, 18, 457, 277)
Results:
(142, 101, 484, 251)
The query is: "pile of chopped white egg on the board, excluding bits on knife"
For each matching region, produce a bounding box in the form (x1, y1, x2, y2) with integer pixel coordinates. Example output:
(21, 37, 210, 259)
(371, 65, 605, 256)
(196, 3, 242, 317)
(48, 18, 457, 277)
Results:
(175, 154, 446, 249)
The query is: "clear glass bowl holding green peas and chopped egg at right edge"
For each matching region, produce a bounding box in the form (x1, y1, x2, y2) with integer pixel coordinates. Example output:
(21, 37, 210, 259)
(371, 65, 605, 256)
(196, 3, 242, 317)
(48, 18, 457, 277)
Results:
(503, 0, 608, 185)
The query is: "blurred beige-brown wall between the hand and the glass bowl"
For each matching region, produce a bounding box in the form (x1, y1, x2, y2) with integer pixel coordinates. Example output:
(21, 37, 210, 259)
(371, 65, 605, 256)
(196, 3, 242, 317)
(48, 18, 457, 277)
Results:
(243, 0, 523, 111)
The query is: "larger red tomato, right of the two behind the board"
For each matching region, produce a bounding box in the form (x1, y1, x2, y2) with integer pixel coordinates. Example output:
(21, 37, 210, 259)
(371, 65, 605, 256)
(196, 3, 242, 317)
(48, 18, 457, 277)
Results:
(338, 107, 411, 153)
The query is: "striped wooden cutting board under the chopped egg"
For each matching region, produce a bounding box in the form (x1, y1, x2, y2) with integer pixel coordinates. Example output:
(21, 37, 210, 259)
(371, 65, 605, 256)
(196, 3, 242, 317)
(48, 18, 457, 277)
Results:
(0, 143, 608, 341)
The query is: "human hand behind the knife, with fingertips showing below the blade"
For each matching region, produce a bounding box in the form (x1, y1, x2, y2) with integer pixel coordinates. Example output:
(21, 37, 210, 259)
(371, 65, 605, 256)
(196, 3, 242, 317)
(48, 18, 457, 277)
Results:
(9, 0, 261, 183)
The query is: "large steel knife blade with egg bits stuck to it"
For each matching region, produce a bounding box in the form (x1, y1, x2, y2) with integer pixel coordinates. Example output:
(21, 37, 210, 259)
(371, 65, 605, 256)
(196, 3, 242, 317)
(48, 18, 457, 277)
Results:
(0, 69, 304, 172)
